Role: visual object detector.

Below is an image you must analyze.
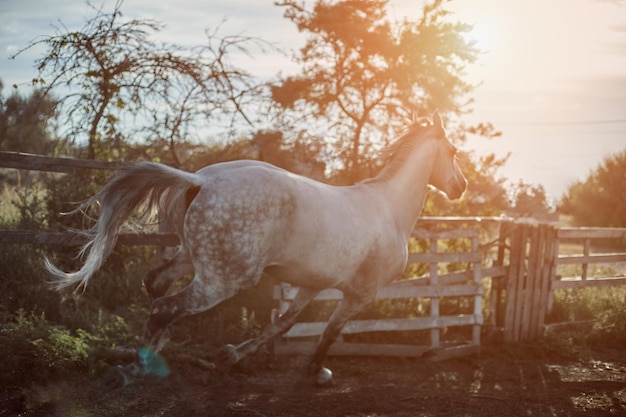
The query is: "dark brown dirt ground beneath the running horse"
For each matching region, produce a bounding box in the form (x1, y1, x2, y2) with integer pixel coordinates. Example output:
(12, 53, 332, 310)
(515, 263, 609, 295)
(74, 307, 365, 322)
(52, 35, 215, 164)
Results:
(0, 346, 626, 417)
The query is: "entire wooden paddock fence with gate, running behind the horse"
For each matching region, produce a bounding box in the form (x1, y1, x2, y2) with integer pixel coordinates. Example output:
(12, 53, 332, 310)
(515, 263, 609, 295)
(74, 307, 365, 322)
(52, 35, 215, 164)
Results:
(0, 152, 626, 360)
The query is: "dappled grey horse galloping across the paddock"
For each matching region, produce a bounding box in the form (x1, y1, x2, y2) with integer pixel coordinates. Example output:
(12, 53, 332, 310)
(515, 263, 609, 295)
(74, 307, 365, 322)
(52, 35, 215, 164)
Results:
(46, 112, 467, 385)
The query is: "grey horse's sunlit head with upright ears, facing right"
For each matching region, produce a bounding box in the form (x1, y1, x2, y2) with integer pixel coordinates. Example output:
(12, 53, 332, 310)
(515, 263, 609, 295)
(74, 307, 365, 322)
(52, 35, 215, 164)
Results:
(428, 112, 467, 200)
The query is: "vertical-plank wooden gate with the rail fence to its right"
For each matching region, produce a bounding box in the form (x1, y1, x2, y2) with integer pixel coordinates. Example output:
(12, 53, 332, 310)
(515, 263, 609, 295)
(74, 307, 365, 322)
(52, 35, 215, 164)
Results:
(490, 220, 626, 342)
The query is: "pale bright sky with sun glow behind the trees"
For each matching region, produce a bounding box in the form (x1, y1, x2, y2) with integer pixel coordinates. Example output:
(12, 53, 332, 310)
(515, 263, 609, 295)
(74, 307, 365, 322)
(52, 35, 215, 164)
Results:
(0, 0, 626, 200)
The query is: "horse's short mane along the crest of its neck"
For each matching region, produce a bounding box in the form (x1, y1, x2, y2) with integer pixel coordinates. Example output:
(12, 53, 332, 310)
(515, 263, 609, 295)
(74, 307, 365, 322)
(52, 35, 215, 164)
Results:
(366, 117, 433, 180)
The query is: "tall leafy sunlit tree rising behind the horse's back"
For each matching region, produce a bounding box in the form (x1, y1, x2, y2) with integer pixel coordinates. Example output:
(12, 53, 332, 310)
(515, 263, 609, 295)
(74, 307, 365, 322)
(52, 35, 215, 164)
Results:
(272, 0, 478, 177)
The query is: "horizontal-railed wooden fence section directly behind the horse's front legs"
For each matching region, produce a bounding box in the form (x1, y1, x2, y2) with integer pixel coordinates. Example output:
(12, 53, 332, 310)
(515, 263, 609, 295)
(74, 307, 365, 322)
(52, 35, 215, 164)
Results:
(274, 218, 506, 359)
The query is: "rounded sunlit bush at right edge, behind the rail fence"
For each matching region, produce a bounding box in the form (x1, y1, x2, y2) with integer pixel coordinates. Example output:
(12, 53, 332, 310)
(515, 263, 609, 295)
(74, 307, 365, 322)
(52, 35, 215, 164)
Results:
(559, 150, 626, 227)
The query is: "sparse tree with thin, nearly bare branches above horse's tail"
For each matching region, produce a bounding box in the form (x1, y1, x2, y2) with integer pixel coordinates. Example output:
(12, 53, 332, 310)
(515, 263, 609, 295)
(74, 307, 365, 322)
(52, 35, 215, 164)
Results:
(12, 0, 261, 166)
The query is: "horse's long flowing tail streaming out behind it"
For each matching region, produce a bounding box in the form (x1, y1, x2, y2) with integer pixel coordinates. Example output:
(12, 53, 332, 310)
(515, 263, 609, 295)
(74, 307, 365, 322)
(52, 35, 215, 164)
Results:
(45, 162, 201, 290)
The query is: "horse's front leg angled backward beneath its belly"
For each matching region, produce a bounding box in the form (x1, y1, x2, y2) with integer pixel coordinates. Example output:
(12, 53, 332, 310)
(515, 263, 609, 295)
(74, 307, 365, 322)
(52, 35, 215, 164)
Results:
(219, 288, 320, 367)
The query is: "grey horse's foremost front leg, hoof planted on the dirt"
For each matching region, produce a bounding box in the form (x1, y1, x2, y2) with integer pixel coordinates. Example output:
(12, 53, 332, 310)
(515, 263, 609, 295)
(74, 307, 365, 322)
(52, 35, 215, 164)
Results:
(309, 293, 374, 386)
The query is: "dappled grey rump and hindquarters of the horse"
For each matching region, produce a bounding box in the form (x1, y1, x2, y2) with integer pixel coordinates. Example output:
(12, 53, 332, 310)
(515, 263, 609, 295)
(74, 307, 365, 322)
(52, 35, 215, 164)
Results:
(183, 161, 296, 275)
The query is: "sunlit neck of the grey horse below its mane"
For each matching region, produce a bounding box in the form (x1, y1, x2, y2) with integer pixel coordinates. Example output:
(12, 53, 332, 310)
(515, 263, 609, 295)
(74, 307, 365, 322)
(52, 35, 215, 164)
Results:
(370, 141, 435, 233)
